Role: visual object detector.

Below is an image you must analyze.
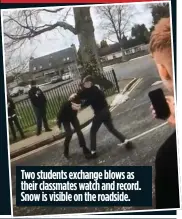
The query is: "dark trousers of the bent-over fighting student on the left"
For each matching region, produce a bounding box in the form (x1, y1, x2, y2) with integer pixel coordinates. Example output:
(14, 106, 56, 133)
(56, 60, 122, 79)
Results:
(63, 117, 86, 153)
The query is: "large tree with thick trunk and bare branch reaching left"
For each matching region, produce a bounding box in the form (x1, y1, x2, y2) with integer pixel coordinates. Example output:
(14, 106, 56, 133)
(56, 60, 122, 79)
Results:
(4, 7, 103, 79)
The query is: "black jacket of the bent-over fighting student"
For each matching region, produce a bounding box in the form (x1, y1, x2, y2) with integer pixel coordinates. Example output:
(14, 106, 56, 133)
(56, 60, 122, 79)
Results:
(57, 101, 77, 127)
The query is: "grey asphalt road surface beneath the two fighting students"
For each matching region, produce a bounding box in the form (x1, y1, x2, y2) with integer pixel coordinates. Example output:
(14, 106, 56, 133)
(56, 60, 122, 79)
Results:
(11, 56, 173, 216)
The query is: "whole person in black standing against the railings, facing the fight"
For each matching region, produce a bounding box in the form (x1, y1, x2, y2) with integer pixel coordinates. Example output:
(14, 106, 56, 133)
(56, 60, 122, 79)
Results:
(28, 81, 52, 135)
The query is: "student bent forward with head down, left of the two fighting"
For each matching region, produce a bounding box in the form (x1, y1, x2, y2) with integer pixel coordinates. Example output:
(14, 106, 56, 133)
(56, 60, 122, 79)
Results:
(57, 95, 90, 158)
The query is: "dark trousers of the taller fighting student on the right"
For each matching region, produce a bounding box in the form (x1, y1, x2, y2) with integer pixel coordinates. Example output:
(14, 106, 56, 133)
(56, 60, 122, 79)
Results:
(90, 109, 125, 151)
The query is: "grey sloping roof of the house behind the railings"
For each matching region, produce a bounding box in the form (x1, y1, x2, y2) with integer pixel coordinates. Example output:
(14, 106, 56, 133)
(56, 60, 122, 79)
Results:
(29, 47, 76, 72)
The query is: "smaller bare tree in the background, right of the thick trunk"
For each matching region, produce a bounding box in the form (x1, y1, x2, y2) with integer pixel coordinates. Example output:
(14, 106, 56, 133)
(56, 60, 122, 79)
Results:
(96, 5, 136, 58)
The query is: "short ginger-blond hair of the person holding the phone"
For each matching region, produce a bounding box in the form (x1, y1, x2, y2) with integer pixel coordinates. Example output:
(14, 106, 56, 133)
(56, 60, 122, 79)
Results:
(149, 18, 171, 53)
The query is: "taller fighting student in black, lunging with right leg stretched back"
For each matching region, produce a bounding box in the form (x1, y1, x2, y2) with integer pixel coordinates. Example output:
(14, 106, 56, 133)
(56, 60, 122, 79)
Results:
(74, 76, 129, 158)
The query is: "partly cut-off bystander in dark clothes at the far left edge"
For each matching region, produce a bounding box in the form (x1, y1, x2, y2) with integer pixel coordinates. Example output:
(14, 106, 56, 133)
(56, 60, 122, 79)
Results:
(7, 95, 25, 141)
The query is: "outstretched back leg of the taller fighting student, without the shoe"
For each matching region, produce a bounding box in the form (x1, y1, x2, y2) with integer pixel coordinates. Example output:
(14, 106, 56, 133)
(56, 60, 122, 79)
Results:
(104, 112, 125, 142)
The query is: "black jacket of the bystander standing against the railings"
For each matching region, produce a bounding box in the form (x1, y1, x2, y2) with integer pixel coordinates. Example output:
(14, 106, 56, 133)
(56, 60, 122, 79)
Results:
(28, 87, 47, 108)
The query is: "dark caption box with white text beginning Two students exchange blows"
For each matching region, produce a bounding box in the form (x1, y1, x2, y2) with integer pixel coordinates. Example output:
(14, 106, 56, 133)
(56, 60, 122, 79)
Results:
(16, 166, 152, 207)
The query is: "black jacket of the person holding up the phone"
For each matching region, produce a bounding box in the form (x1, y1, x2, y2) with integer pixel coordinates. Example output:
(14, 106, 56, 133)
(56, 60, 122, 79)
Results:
(155, 132, 179, 209)
